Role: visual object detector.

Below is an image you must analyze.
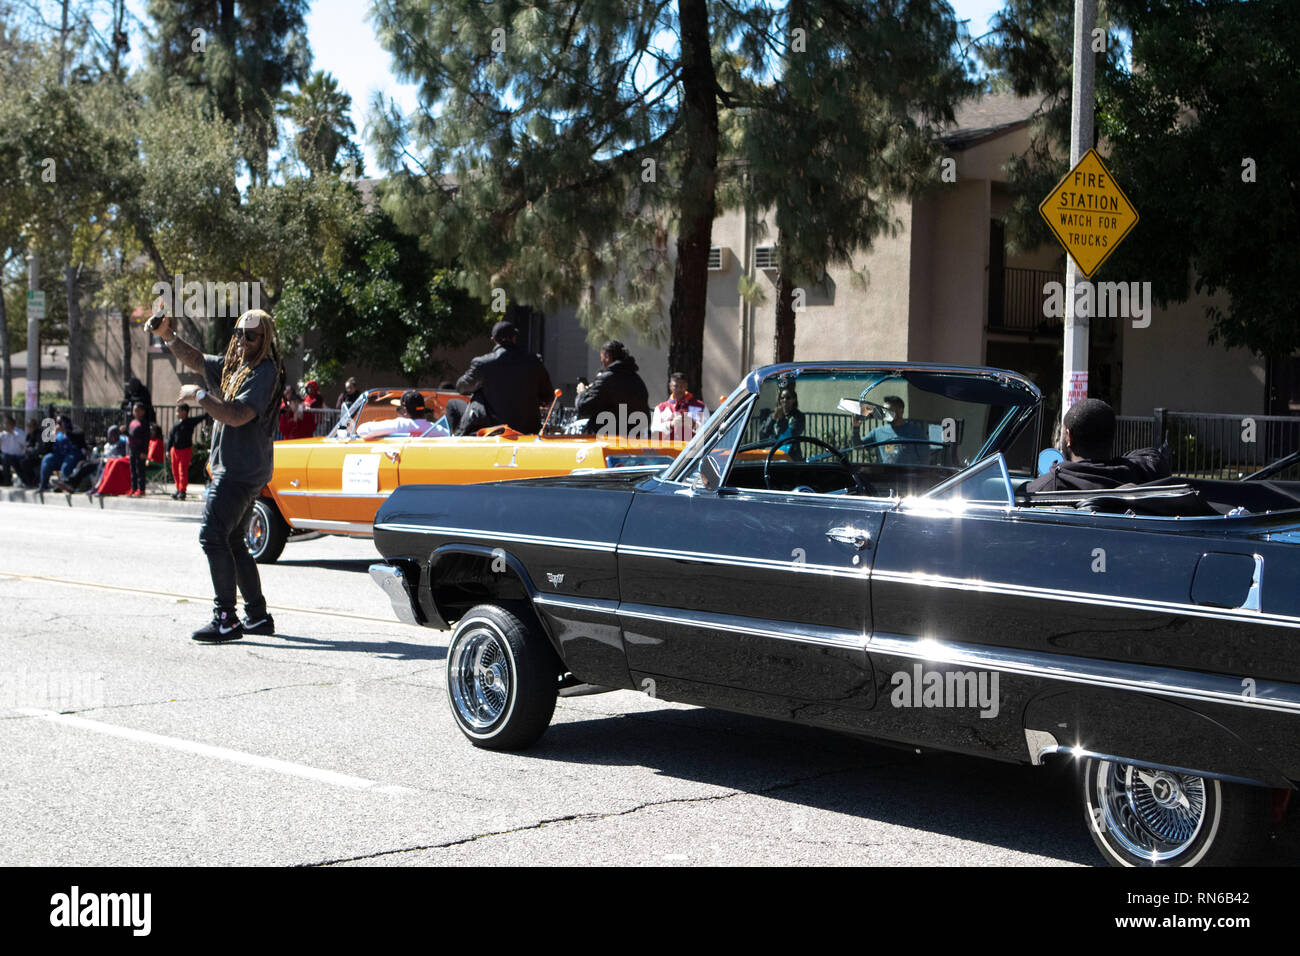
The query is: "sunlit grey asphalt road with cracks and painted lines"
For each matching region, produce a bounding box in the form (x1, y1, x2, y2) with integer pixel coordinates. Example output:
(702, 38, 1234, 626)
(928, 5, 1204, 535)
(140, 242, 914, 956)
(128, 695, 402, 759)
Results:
(0, 503, 1289, 866)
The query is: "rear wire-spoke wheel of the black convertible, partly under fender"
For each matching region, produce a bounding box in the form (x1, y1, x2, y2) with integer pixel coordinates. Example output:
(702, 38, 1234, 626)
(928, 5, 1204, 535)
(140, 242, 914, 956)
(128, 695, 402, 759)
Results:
(1082, 757, 1271, 866)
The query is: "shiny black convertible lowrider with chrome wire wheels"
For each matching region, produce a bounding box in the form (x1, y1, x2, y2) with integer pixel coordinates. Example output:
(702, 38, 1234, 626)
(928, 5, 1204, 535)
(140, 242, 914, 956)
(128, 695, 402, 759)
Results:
(371, 363, 1300, 866)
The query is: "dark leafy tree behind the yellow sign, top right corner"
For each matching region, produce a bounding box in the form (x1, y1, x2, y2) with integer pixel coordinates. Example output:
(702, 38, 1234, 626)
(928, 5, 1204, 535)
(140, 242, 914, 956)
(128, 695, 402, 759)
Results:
(987, 0, 1300, 356)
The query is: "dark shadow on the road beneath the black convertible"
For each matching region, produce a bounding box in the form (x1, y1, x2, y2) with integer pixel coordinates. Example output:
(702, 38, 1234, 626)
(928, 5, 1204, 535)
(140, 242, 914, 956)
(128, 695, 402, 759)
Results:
(501, 701, 1300, 865)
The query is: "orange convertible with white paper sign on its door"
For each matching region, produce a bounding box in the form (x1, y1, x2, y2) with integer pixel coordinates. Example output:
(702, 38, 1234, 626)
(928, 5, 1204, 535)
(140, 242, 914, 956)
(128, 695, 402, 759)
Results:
(244, 388, 684, 563)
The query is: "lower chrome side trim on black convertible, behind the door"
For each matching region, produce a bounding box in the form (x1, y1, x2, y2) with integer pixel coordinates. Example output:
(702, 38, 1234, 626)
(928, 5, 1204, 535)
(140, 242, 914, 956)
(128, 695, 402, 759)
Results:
(867, 633, 1300, 714)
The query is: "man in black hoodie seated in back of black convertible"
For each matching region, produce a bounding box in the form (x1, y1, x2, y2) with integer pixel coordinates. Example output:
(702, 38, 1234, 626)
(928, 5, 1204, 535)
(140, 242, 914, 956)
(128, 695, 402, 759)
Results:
(1024, 398, 1170, 492)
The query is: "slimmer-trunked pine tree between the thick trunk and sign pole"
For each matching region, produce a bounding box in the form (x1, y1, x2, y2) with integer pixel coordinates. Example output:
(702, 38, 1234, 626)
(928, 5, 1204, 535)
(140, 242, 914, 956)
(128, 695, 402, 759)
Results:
(733, 0, 974, 362)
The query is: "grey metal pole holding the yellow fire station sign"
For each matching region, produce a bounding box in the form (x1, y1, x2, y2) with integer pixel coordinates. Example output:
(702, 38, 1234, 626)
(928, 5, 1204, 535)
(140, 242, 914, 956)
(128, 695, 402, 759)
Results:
(1061, 0, 1097, 418)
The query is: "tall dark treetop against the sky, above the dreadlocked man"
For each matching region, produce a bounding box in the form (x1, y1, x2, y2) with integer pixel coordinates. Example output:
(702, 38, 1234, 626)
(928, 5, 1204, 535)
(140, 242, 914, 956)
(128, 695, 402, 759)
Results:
(148, 0, 311, 182)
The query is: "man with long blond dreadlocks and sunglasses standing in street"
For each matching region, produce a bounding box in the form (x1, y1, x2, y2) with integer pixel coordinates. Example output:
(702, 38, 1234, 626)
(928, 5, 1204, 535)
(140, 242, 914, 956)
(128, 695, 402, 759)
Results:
(146, 308, 285, 644)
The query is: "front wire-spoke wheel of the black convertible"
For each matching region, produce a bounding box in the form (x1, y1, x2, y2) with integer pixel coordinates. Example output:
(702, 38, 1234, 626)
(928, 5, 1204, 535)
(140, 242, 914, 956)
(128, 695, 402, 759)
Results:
(447, 605, 563, 750)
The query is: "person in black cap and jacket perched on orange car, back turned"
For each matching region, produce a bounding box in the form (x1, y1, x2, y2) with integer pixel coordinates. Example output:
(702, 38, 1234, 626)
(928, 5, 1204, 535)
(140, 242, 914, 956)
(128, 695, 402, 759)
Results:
(456, 321, 555, 434)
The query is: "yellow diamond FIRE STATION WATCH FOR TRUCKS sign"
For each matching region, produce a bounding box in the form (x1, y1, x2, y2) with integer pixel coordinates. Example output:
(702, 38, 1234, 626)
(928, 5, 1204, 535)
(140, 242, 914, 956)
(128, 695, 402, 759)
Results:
(1039, 150, 1138, 278)
